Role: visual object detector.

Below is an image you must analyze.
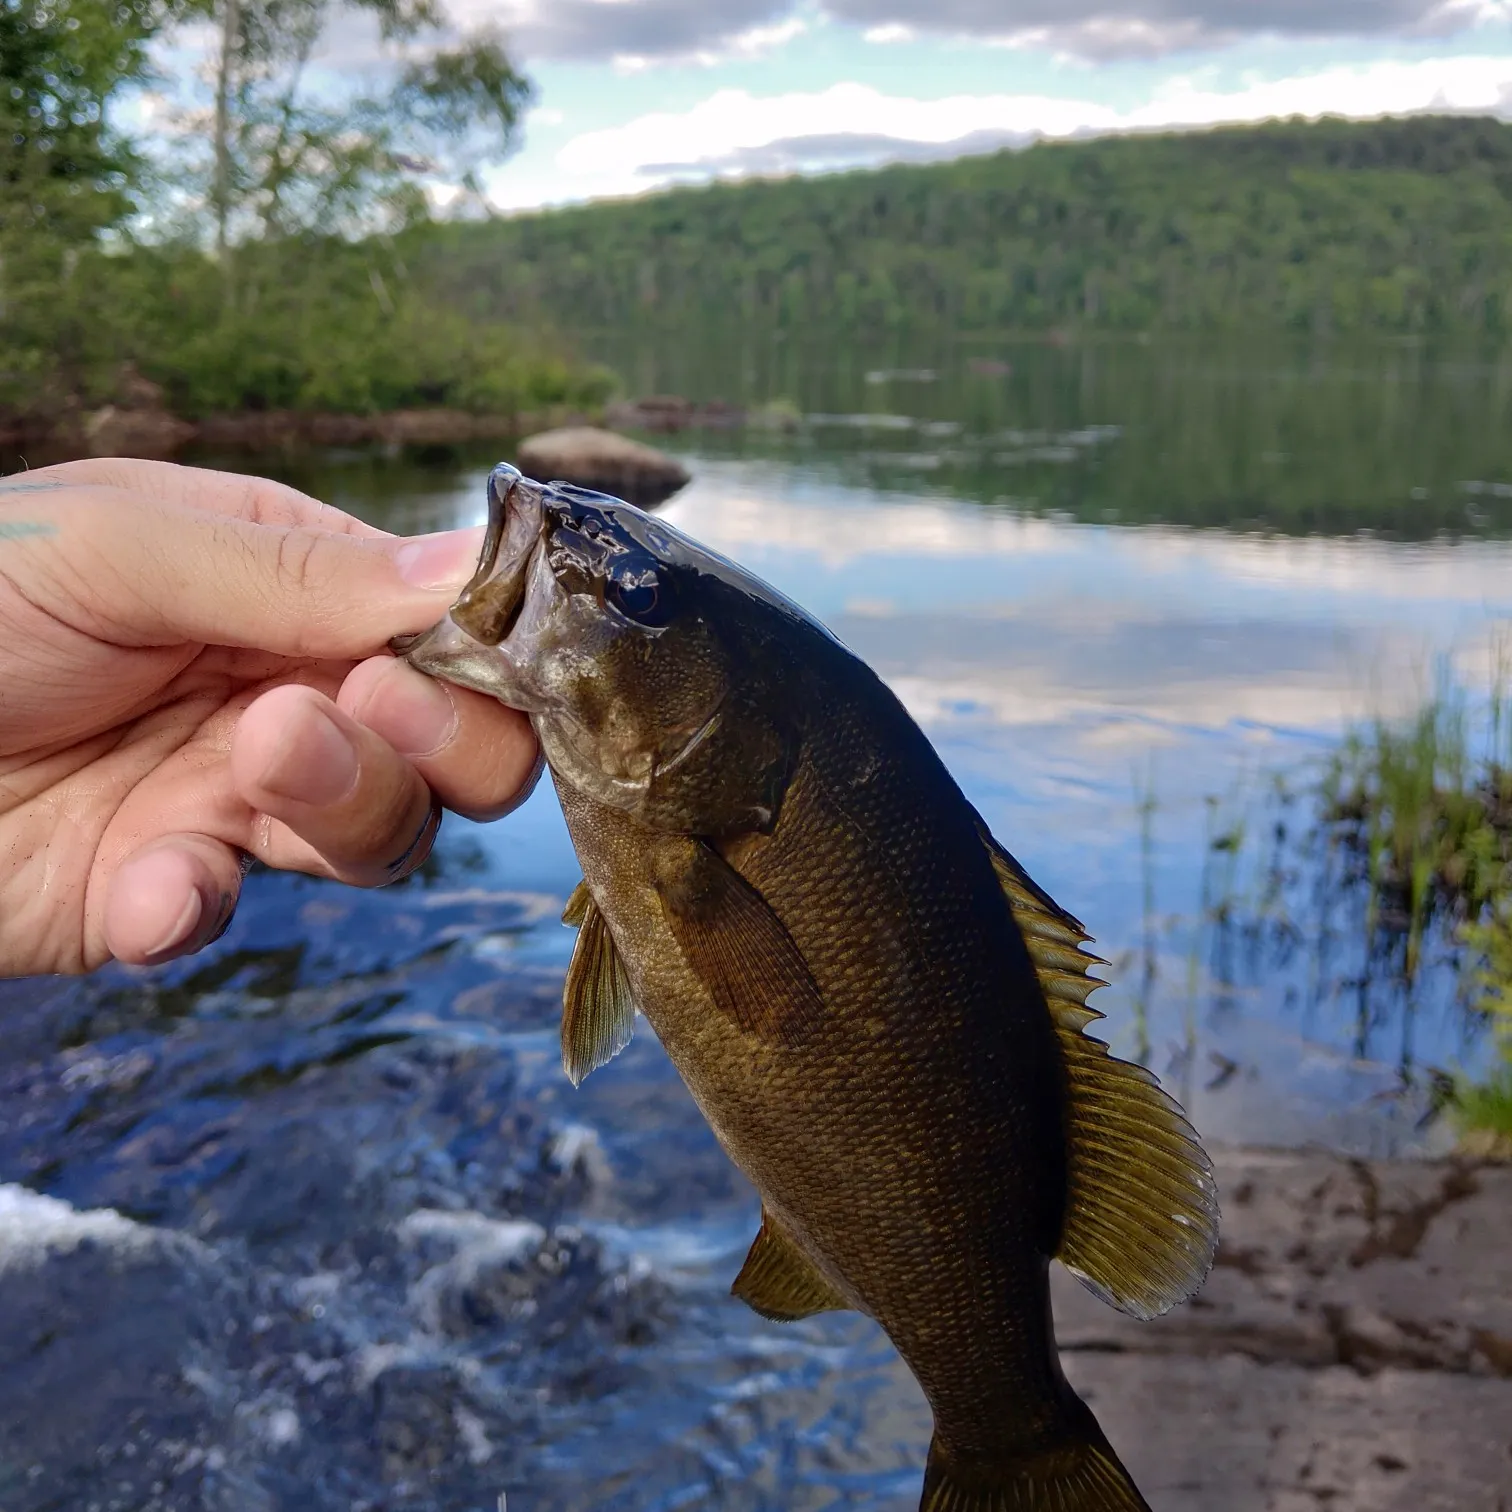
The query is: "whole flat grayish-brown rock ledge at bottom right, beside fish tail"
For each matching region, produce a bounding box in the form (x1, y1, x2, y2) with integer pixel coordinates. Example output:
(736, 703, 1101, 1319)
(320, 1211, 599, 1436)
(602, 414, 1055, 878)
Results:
(1057, 1151, 1512, 1512)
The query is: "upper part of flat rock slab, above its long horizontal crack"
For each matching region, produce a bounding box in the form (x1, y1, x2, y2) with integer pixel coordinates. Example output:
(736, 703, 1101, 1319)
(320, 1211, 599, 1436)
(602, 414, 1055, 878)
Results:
(1054, 1151, 1512, 1384)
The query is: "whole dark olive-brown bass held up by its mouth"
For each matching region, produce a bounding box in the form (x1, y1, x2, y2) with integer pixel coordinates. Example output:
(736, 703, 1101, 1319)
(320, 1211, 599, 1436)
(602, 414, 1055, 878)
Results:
(404, 466, 1217, 1512)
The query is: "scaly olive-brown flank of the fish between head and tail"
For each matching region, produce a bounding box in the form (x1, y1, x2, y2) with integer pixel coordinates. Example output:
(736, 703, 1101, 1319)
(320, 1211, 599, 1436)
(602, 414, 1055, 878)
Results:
(562, 688, 1064, 1450)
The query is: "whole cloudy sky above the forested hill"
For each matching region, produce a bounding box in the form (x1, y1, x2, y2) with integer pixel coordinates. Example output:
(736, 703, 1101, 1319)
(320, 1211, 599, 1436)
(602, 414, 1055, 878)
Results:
(156, 0, 1512, 210)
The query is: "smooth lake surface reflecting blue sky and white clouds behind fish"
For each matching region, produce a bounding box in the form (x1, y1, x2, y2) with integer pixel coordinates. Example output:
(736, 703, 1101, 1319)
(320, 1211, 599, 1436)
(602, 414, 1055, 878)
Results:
(201, 420, 1512, 1149)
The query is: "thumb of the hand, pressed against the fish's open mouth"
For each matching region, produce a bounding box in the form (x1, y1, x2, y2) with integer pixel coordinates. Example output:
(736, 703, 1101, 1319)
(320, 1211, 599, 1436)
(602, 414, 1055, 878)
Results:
(27, 488, 481, 659)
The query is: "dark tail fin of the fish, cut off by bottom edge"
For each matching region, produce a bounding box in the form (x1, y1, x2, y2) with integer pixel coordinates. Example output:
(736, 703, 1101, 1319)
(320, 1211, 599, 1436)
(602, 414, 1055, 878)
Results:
(919, 1403, 1151, 1512)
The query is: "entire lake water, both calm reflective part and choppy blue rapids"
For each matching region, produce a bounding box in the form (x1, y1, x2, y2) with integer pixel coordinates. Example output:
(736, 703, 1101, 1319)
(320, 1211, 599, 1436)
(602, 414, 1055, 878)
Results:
(0, 340, 1512, 1509)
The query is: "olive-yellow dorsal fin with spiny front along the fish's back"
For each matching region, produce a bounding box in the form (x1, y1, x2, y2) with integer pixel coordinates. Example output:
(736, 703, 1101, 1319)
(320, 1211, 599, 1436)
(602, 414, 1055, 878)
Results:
(981, 830, 1219, 1318)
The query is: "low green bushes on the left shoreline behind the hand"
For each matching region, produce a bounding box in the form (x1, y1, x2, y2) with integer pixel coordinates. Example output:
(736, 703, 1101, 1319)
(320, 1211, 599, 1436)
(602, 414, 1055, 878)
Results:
(10, 236, 614, 419)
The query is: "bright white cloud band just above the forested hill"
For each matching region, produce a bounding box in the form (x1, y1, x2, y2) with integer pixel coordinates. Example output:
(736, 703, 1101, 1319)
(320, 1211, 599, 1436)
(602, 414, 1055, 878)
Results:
(499, 56, 1512, 206)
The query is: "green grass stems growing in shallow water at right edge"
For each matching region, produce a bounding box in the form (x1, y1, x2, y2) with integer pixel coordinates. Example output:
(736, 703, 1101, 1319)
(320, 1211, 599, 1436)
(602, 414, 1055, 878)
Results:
(1136, 653, 1512, 1148)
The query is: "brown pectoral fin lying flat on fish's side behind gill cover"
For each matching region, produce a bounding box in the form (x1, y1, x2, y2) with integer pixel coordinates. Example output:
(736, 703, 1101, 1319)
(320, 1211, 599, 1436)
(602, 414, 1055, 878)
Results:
(655, 841, 824, 1045)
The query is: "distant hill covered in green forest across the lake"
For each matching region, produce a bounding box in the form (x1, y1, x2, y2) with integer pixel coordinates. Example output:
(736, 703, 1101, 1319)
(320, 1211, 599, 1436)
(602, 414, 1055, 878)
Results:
(402, 116, 1512, 336)
